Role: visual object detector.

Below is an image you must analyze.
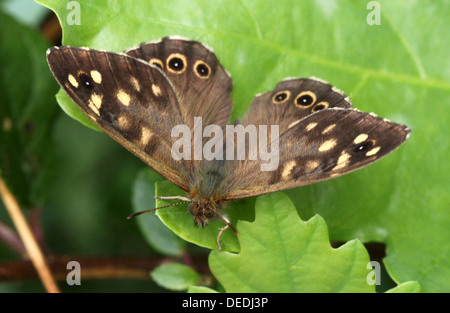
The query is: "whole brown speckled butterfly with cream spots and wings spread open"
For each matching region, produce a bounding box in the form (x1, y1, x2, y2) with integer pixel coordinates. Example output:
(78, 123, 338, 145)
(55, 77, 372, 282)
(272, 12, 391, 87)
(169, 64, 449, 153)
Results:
(47, 37, 410, 247)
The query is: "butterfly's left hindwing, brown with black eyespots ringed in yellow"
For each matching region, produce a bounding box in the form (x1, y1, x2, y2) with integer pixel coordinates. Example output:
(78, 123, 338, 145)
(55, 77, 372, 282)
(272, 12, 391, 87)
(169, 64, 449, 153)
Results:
(125, 37, 232, 129)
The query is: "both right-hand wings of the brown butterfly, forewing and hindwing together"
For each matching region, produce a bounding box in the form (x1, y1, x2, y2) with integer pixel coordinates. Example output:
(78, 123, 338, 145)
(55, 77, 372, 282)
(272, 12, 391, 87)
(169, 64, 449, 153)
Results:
(224, 79, 410, 200)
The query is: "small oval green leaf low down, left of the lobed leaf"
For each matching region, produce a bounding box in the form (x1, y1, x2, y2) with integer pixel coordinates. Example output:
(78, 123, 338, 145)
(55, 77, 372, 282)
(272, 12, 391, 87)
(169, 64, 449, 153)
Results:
(150, 263, 201, 290)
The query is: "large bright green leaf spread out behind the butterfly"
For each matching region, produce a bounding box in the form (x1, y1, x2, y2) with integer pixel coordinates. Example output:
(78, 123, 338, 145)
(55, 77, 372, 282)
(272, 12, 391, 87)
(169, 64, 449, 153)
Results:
(40, 0, 450, 291)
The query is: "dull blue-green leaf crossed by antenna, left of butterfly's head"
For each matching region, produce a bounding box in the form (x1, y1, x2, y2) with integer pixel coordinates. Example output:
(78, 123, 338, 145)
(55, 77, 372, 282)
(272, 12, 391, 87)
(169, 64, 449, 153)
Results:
(132, 168, 186, 256)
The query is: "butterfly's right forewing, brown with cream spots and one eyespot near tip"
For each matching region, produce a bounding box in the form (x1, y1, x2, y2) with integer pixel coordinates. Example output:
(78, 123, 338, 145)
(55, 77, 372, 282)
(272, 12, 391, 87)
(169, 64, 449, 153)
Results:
(224, 79, 410, 200)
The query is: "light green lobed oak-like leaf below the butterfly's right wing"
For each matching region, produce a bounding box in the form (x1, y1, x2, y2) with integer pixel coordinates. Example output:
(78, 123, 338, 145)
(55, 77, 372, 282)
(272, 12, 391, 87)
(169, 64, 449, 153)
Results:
(209, 193, 374, 292)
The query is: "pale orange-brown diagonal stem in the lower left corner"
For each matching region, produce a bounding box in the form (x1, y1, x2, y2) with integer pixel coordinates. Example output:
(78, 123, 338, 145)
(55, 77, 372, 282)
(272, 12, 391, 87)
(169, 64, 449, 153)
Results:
(0, 178, 59, 293)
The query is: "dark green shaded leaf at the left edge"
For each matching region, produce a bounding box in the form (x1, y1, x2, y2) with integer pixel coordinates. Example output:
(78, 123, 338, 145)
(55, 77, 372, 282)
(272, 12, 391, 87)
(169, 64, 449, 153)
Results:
(0, 11, 58, 207)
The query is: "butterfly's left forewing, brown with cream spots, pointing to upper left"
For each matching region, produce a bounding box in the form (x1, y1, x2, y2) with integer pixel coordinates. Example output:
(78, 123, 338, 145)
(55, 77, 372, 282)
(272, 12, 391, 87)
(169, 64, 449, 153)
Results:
(47, 47, 189, 191)
